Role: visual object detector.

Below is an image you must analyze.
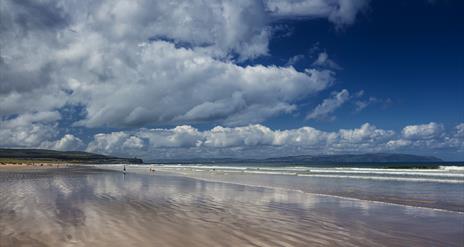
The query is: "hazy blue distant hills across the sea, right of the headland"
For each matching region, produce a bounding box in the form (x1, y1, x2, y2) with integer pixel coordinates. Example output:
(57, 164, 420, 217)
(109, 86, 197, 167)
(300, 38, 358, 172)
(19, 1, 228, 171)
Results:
(152, 153, 444, 164)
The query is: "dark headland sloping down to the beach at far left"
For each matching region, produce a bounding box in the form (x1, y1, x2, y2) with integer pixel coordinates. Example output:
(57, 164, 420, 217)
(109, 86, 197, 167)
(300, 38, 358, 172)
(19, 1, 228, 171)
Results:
(0, 148, 143, 164)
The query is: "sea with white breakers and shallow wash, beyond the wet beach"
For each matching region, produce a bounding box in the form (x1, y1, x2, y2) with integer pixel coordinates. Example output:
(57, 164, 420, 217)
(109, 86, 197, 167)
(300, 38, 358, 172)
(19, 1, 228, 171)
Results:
(152, 165, 464, 213)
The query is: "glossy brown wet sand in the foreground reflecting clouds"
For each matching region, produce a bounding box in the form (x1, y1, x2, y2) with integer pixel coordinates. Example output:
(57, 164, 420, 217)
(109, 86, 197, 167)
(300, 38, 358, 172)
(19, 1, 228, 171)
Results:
(0, 168, 464, 247)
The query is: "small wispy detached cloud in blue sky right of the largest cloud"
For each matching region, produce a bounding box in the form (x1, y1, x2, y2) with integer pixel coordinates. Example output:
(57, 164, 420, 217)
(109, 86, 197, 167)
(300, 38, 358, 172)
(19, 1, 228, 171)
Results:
(306, 89, 350, 119)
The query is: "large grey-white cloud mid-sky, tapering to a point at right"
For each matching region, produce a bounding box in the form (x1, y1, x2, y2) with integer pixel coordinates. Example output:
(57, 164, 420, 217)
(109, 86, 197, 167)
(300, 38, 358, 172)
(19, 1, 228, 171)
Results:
(71, 41, 334, 127)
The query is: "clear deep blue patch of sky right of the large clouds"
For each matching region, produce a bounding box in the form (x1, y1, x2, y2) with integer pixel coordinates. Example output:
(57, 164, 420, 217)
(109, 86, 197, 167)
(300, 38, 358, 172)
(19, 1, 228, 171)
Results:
(260, 1, 464, 129)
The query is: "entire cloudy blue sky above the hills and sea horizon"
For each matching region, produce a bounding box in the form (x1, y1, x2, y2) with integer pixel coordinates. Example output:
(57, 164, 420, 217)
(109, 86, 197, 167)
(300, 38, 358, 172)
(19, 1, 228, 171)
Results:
(0, 0, 464, 161)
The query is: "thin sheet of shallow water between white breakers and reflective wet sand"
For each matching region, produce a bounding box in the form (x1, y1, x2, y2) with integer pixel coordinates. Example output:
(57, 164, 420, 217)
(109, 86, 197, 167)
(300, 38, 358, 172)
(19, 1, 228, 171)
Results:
(152, 166, 464, 213)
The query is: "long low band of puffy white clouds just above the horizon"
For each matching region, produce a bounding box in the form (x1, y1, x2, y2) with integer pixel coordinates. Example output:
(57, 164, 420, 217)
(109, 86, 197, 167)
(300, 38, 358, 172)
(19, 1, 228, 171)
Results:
(87, 123, 464, 159)
